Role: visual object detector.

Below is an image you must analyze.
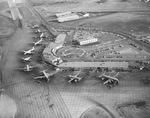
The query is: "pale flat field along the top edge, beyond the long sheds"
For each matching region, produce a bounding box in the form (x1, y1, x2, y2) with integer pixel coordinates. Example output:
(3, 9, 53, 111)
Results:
(28, 0, 149, 12)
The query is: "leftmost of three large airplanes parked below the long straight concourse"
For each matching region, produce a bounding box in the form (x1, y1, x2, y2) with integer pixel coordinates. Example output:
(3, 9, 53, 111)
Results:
(34, 69, 59, 82)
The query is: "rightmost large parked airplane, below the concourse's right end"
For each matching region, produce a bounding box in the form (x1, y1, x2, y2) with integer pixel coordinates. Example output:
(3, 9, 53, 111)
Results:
(99, 72, 119, 87)
